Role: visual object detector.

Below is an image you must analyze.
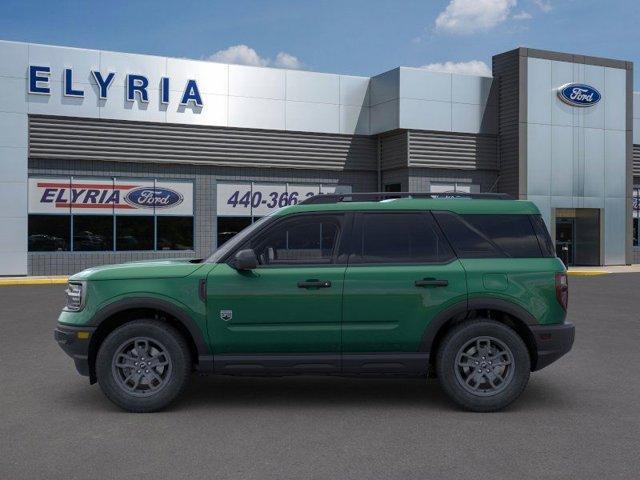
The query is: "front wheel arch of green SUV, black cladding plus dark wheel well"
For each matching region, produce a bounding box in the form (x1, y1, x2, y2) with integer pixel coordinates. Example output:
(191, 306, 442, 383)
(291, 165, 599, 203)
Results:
(88, 297, 213, 383)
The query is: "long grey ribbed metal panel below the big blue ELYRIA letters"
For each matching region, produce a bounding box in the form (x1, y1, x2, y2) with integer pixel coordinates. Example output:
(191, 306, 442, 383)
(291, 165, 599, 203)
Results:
(29, 115, 377, 170)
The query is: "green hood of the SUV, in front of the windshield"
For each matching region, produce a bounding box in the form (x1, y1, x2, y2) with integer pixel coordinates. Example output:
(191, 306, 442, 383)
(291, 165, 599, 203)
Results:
(69, 258, 204, 281)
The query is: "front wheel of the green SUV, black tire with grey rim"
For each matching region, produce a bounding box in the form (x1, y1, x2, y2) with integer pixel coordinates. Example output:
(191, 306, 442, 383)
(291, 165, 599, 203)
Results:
(96, 320, 191, 413)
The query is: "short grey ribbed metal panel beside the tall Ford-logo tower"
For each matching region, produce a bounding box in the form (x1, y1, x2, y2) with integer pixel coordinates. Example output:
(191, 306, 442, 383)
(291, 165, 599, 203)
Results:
(409, 130, 498, 170)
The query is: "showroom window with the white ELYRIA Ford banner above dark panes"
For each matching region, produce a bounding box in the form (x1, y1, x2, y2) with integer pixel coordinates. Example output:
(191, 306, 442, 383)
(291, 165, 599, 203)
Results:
(28, 177, 194, 252)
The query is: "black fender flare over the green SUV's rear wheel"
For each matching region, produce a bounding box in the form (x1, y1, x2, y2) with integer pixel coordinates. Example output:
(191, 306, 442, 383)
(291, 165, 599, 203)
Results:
(420, 297, 538, 352)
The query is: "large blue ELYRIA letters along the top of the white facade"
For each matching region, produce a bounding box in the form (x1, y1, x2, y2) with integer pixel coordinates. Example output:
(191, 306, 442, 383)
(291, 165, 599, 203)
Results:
(28, 65, 203, 107)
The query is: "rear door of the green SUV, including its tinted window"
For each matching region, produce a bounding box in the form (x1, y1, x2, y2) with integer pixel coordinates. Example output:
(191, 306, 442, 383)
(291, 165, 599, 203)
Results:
(342, 211, 467, 373)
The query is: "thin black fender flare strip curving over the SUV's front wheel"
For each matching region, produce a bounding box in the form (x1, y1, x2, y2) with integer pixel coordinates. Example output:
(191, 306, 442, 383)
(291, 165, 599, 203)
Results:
(88, 297, 213, 370)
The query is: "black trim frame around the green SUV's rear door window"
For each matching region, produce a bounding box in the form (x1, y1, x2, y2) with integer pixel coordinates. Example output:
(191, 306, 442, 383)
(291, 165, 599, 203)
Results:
(347, 210, 458, 267)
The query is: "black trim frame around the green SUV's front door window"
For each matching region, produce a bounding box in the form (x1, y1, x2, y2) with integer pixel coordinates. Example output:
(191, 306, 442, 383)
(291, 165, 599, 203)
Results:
(234, 212, 346, 269)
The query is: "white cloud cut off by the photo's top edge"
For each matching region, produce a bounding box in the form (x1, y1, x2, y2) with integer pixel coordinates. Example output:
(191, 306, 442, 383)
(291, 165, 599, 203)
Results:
(436, 0, 516, 34)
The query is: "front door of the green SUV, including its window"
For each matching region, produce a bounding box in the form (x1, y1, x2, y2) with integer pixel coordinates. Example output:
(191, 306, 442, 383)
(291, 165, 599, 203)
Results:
(207, 214, 346, 370)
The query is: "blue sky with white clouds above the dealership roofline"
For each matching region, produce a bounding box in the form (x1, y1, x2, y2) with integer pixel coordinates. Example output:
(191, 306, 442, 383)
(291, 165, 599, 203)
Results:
(0, 0, 640, 84)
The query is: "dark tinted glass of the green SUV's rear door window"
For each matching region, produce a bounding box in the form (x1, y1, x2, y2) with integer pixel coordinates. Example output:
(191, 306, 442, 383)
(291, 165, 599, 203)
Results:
(356, 212, 453, 263)
